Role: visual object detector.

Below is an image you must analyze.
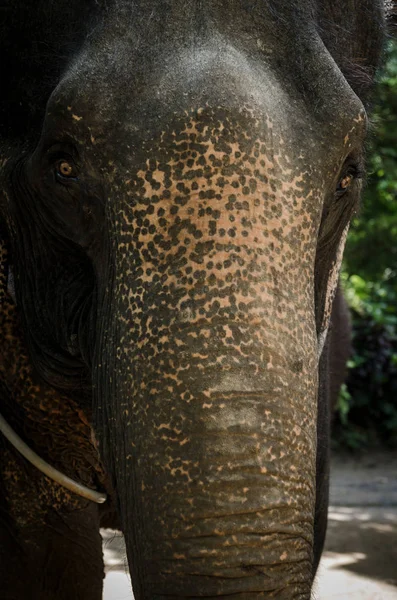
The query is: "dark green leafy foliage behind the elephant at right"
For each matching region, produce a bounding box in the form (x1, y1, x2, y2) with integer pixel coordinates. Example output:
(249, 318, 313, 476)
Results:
(334, 42, 397, 449)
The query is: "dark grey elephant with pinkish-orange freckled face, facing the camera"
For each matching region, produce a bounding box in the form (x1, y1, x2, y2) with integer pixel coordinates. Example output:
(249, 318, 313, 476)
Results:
(0, 0, 396, 600)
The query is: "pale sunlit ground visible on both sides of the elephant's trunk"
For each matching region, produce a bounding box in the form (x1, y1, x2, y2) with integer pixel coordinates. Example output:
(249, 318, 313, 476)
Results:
(103, 452, 397, 600)
